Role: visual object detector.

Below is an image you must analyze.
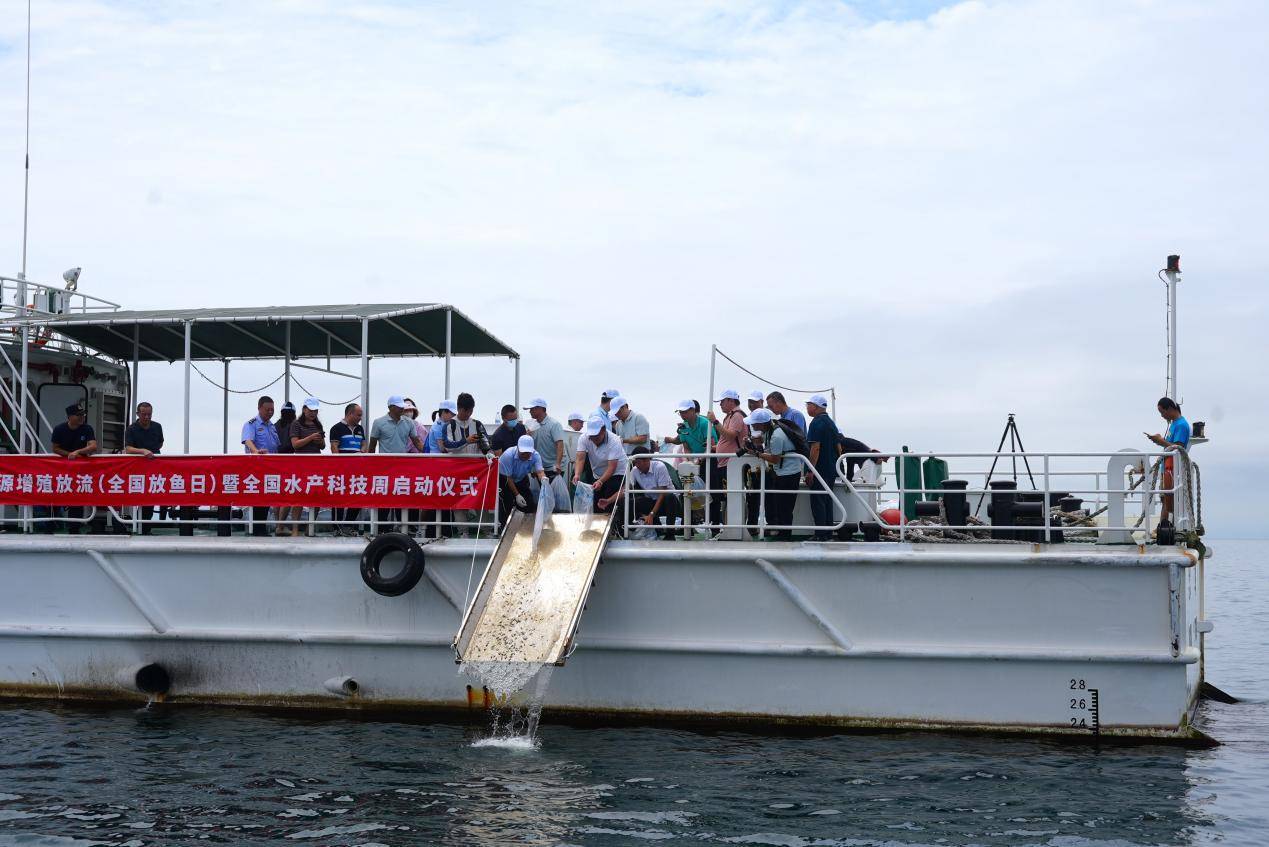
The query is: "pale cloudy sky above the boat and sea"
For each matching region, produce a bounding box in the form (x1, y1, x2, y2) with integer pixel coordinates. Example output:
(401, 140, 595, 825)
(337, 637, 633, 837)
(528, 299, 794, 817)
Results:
(0, 0, 1269, 537)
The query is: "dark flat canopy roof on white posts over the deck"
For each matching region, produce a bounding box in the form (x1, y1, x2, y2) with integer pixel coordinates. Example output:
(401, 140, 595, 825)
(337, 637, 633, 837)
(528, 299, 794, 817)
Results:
(5, 303, 519, 362)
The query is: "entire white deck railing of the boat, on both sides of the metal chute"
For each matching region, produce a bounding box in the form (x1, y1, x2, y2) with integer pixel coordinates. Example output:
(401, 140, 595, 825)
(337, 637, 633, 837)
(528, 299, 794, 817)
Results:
(0, 450, 1199, 544)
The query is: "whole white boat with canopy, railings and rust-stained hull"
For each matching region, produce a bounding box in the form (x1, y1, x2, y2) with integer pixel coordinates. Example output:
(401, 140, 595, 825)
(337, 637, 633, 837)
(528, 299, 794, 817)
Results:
(0, 262, 1212, 739)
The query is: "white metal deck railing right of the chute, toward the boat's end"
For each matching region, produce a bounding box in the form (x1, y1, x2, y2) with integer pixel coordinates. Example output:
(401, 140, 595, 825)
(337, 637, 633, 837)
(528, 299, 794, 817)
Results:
(604, 450, 1195, 544)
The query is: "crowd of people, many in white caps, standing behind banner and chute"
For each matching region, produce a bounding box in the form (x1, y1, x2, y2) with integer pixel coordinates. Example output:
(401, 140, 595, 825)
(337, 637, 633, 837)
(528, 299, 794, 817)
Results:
(37, 389, 886, 540)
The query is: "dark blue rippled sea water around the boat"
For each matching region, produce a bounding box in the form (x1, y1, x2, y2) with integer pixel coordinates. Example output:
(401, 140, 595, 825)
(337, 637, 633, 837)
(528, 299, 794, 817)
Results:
(0, 541, 1269, 847)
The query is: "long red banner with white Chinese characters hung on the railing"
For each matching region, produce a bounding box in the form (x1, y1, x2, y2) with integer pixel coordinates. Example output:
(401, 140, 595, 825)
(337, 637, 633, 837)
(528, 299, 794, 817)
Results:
(0, 453, 497, 509)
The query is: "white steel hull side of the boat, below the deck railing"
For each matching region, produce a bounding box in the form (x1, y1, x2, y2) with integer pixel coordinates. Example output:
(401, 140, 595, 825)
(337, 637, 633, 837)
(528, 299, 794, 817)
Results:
(0, 536, 1204, 738)
